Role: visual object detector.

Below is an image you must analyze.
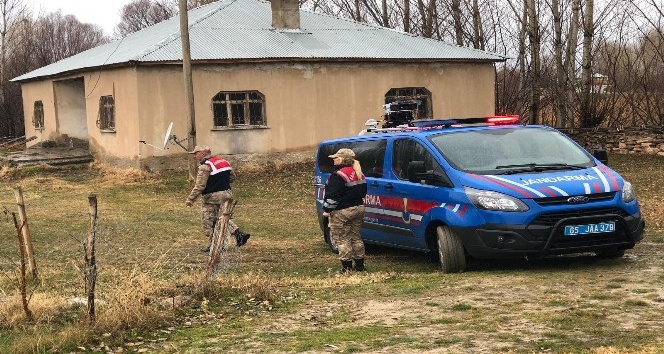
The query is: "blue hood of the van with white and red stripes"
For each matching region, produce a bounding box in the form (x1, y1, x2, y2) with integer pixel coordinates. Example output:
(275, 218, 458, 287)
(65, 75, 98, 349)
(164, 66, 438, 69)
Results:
(462, 164, 624, 199)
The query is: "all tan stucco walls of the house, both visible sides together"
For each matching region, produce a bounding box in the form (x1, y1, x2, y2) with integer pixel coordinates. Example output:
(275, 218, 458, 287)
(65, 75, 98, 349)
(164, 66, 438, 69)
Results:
(22, 63, 495, 166)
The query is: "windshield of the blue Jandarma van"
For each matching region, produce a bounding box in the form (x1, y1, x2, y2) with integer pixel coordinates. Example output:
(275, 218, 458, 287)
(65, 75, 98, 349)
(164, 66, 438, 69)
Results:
(431, 128, 595, 174)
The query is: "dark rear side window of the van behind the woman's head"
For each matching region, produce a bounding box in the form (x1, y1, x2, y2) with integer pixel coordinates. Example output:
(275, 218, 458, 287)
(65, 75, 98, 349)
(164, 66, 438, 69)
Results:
(318, 139, 387, 178)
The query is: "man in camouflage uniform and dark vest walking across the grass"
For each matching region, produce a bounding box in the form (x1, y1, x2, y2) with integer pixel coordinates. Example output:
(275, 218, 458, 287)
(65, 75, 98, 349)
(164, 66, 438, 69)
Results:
(185, 145, 251, 252)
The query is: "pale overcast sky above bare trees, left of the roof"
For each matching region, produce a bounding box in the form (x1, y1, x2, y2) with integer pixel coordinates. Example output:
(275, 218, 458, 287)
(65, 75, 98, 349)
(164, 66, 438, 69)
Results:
(26, 0, 136, 36)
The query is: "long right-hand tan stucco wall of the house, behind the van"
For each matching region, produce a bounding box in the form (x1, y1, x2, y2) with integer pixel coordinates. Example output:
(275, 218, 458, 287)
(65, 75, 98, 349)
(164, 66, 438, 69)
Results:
(138, 64, 494, 156)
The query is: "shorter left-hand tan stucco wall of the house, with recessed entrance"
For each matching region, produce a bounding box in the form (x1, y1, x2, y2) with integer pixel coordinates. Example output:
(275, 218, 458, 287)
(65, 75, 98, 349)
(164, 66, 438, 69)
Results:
(21, 68, 139, 162)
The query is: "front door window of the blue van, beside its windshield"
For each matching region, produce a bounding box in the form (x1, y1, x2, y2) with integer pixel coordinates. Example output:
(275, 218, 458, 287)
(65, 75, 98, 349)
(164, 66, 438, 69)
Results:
(392, 139, 445, 180)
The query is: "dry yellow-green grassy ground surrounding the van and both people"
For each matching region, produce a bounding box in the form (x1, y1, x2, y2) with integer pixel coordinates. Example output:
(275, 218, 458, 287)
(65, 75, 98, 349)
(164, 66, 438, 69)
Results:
(0, 155, 664, 354)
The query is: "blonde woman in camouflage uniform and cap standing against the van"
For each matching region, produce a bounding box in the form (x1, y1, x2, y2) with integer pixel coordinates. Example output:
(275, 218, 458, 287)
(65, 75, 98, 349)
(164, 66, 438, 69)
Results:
(323, 149, 367, 273)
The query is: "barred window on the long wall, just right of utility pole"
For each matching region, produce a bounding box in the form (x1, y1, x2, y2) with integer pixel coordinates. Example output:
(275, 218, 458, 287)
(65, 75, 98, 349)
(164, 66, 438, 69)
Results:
(212, 91, 267, 128)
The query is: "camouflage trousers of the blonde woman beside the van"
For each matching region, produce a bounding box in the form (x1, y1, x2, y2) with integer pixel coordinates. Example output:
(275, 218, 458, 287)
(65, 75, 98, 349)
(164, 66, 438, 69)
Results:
(329, 205, 364, 261)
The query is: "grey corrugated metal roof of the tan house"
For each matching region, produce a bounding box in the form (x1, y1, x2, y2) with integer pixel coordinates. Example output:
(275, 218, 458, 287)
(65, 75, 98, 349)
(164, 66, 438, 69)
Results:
(12, 0, 506, 81)
